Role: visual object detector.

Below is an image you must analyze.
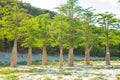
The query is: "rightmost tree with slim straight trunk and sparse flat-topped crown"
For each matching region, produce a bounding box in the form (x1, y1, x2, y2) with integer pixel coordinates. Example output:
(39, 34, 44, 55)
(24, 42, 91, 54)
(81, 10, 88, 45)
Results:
(98, 12, 117, 65)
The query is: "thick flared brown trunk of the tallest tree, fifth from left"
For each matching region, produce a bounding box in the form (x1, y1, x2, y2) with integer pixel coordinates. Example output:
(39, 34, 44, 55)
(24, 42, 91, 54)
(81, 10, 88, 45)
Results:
(68, 46, 74, 66)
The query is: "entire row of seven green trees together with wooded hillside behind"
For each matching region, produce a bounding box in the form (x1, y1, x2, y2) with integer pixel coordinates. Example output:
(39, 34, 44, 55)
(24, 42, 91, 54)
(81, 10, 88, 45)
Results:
(0, 0, 120, 66)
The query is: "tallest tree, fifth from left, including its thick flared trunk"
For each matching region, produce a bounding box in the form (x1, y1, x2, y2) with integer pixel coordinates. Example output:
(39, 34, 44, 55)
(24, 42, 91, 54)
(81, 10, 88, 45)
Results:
(59, 0, 81, 66)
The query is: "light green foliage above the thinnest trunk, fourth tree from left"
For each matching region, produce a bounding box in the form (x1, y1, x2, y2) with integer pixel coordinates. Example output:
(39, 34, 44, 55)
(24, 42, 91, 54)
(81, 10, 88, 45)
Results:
(49, 15, 69, 47)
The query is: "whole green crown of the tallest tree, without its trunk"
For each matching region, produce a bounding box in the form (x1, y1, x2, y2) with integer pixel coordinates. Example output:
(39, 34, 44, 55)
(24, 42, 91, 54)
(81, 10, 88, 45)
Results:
(56, 0, 81, 47)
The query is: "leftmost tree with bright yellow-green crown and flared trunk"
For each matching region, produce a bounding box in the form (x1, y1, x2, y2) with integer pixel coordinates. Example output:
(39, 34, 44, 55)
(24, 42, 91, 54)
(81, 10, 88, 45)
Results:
(1, 0, 27, 67)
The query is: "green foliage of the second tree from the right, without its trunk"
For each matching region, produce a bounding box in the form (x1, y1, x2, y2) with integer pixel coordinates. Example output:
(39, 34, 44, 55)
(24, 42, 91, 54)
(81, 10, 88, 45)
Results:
(80, 8, 100, 52)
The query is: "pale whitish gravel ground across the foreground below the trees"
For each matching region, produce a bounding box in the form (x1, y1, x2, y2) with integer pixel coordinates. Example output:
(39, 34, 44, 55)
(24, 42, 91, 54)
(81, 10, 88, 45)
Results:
(0, 65, 120, 80)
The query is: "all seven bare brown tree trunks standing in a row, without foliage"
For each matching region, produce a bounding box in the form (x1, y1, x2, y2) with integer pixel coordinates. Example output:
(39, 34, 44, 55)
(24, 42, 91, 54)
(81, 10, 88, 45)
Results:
(10, 39, 110, 67)
